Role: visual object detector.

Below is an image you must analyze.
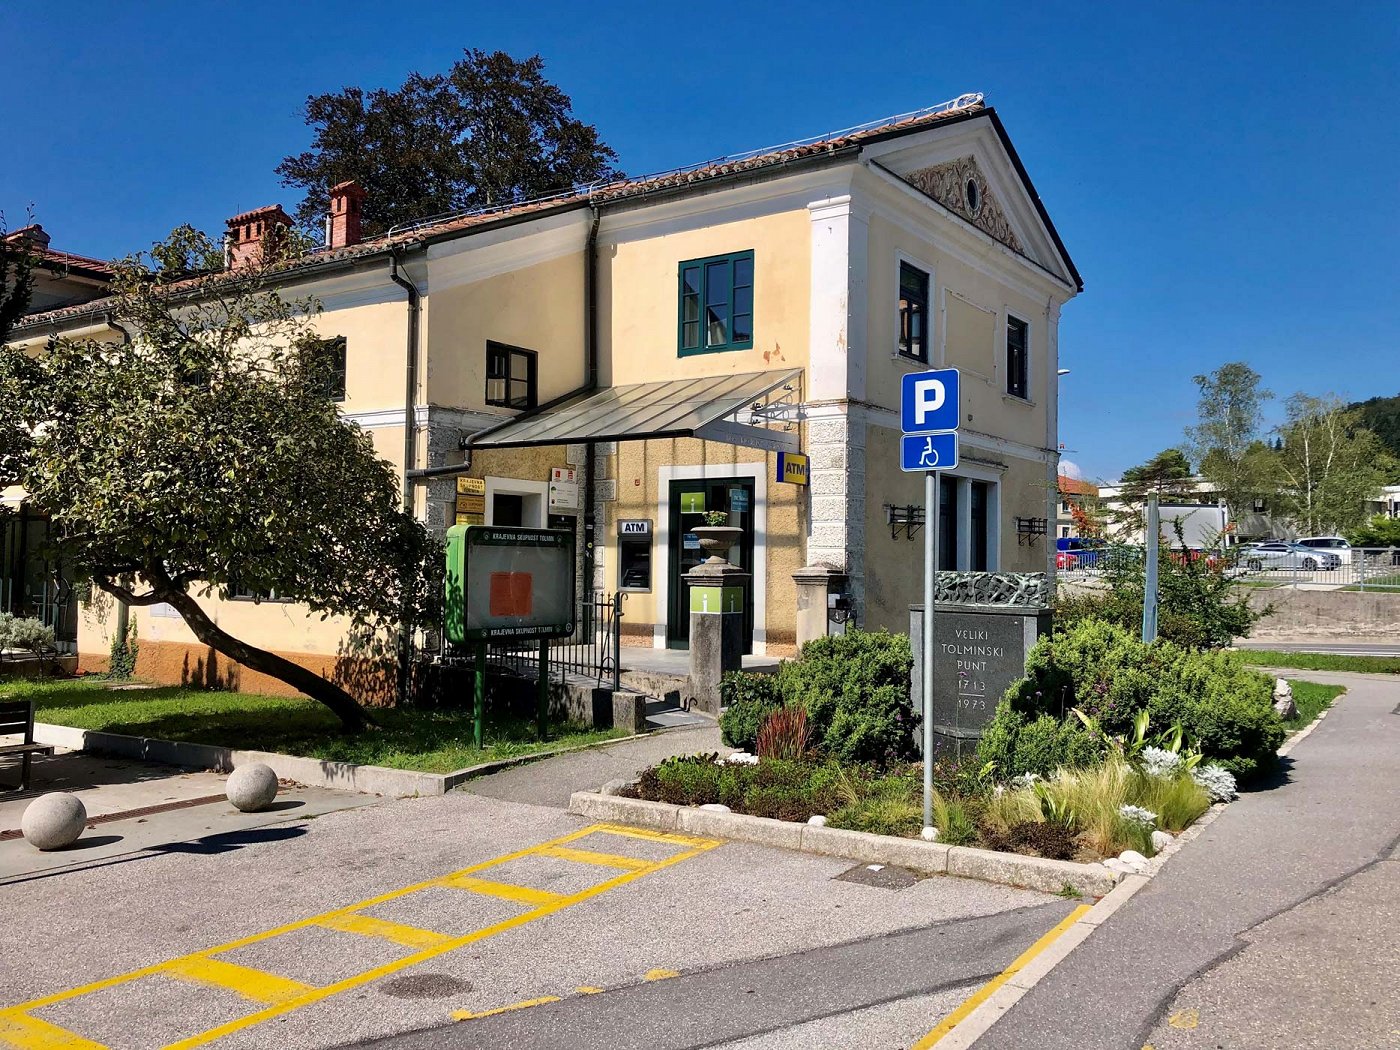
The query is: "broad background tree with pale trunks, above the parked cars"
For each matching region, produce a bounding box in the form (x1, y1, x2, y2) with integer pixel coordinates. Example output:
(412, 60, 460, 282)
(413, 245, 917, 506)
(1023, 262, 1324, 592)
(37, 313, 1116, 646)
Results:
(1275, 393, 1386, 536)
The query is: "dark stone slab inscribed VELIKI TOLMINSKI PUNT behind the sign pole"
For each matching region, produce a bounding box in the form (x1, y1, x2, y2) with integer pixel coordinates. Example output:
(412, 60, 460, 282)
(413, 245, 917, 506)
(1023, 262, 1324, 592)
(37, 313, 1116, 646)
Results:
(909, 602, 1050, 756)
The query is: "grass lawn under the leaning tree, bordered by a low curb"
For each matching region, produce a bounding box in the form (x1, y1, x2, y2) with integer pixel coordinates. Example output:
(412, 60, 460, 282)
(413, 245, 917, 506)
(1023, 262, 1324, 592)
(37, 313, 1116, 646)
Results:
(0, 679, 623, 773)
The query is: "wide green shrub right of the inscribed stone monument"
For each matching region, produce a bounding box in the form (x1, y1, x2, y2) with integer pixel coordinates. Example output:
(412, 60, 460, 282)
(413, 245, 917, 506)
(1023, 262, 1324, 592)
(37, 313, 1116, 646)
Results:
(996, 620, 1285, 778)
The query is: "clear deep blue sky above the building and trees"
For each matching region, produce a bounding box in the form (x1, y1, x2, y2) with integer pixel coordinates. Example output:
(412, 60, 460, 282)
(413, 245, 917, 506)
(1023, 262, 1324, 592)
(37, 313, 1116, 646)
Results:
(0, 0, 1400, 480)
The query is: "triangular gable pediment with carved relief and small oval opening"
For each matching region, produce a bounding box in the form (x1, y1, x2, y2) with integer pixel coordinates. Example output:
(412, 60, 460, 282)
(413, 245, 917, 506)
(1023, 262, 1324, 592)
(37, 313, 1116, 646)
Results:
(861, 109, 1079, 287)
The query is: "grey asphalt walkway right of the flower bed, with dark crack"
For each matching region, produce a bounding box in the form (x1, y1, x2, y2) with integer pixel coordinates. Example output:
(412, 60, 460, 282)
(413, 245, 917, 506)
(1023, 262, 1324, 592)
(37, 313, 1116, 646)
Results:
(976, 671, 1400, 1050)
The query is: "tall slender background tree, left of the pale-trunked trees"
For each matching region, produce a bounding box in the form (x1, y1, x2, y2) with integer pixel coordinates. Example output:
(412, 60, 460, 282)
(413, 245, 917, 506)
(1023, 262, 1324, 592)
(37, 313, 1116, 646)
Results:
(1186, 361, 1274, 519)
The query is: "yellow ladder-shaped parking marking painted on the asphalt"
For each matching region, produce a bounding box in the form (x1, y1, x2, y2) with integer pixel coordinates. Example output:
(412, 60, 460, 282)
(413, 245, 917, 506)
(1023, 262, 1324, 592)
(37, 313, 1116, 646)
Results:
(0, 825, 721, 1050)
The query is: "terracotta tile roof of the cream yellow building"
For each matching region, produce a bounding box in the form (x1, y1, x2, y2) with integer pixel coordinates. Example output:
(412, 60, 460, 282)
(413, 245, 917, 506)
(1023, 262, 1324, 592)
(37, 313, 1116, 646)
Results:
(15, 94, 990, 329)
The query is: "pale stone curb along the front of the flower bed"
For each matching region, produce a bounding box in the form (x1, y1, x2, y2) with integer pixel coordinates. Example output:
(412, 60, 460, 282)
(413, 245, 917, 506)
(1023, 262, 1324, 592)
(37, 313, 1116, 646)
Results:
(568, 791, 1119, 896)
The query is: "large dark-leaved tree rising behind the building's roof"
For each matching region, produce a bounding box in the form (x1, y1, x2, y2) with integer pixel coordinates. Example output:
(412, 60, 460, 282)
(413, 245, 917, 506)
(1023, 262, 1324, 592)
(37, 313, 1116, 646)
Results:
(277, 49, 620, 237)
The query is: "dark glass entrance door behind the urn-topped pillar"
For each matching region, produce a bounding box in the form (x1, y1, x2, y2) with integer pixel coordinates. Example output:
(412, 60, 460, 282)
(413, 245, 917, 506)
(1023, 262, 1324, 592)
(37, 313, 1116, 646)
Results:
(666, 477, 753, 652)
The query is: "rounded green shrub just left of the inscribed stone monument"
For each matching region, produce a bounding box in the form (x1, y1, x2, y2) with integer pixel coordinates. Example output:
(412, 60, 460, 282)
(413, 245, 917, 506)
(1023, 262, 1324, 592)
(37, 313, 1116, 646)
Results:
(778, 630, 918, 766)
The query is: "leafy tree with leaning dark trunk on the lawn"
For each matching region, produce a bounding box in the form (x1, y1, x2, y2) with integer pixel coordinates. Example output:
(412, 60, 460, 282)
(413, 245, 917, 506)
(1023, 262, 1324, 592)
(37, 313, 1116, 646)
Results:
(6, 234, 434, 728)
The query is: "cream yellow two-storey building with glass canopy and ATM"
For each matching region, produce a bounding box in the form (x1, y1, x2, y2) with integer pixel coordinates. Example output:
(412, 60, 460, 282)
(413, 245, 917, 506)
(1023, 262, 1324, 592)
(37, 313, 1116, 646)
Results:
(17, 97, 1081, 687)
